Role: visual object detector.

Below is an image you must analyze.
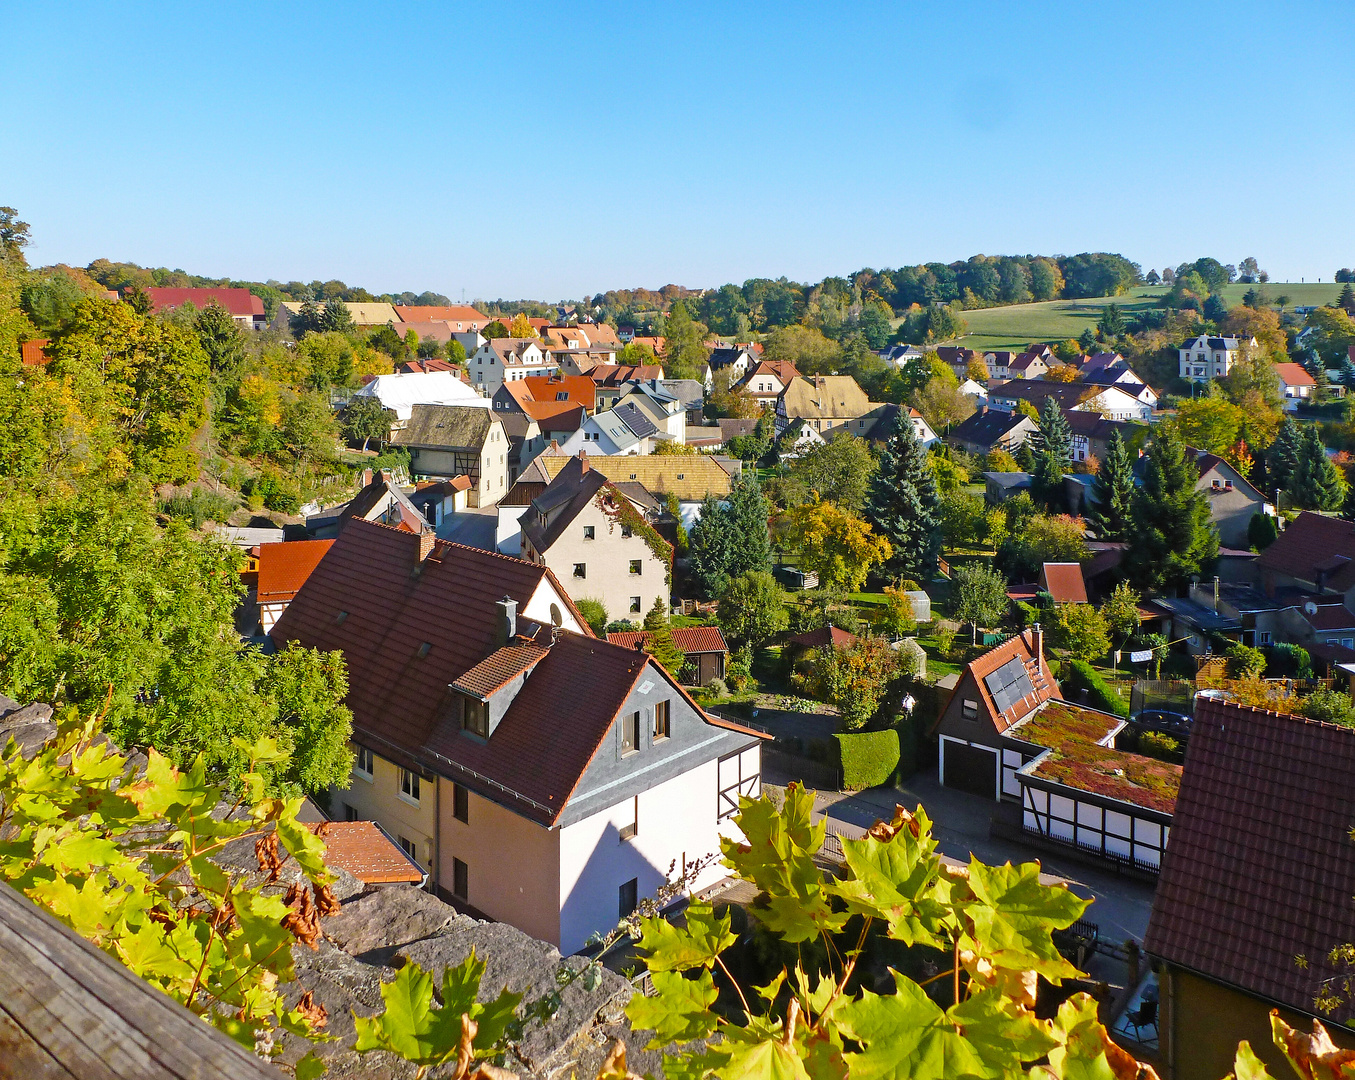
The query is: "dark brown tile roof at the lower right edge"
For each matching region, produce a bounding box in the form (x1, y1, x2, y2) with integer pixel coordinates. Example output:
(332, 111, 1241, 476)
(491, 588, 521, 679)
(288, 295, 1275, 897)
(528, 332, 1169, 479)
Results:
(1144, 701, 1355, 1022)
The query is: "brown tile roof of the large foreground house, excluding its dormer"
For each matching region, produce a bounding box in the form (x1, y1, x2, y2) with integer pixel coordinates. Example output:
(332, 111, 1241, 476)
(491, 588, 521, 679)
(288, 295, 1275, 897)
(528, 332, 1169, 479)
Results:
(272, 522, 720, 824)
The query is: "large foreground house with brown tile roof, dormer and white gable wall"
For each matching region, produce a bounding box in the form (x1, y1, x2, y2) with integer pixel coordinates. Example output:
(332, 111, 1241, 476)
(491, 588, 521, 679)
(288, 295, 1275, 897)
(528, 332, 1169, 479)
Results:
(272, 523, 762, 953)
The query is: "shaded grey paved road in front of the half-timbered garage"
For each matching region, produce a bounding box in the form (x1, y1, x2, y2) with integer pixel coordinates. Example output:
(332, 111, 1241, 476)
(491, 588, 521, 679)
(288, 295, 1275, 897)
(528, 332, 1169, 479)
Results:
(766, 772, 1153, 943)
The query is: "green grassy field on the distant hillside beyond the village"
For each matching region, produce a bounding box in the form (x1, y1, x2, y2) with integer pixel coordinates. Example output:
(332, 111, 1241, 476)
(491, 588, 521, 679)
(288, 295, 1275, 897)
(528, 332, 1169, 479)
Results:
(915, 282, 1341, 351)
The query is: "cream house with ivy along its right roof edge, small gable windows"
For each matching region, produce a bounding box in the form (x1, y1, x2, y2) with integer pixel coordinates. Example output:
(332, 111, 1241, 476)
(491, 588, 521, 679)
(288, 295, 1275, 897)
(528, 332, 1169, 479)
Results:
(519, 454, 672, 622)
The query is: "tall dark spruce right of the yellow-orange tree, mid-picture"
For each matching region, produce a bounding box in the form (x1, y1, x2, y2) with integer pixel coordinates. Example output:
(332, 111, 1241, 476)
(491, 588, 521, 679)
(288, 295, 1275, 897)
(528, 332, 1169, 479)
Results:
(866, 409, 940, 581)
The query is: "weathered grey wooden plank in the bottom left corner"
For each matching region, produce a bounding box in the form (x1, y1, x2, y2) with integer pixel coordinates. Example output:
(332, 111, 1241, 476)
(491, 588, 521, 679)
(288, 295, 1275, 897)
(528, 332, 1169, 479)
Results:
(0, 884, 276, 1080)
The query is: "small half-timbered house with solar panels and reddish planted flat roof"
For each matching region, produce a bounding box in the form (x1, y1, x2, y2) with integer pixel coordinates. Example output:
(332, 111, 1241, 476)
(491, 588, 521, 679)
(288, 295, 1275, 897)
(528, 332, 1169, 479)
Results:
(931, 626, 1182, 871)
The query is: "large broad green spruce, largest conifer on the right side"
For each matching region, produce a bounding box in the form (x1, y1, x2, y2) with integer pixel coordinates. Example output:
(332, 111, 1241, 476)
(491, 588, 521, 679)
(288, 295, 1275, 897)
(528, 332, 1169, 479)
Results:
(1127, 424, 1218, 589)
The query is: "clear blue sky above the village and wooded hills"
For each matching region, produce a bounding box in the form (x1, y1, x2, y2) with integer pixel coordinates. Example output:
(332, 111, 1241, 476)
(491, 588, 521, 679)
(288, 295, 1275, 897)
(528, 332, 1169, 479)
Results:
(0, 3, 1355, 299)
